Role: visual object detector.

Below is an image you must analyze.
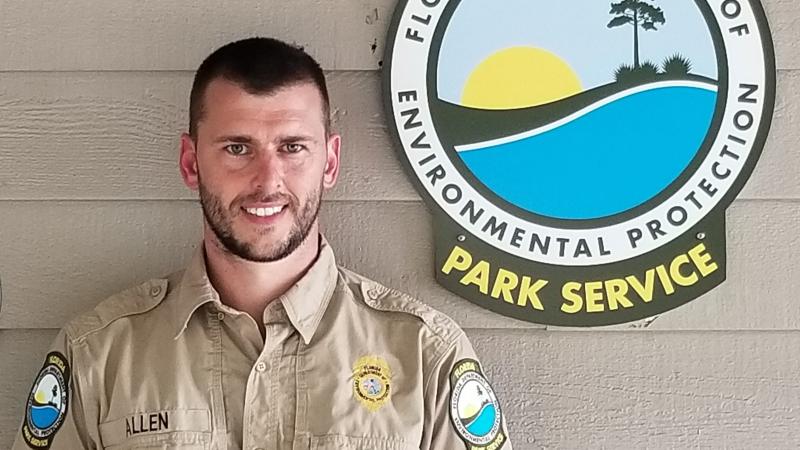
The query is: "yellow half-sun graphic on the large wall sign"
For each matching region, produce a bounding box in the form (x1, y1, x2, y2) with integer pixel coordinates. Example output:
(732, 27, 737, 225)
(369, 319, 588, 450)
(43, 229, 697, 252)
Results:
(461, 47, 583, 109)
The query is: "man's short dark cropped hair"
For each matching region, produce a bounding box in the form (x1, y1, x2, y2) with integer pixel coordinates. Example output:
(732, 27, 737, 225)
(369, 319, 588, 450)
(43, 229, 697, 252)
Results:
(189, 37, 330, 140)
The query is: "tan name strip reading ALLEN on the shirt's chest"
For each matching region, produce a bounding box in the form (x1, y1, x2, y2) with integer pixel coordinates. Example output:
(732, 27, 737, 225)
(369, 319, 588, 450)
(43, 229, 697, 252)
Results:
(99, 409, 211, 446)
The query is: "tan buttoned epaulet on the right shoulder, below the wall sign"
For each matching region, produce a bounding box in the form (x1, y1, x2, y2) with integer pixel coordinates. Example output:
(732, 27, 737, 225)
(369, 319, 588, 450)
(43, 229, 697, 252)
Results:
(339, 267, 464, 347)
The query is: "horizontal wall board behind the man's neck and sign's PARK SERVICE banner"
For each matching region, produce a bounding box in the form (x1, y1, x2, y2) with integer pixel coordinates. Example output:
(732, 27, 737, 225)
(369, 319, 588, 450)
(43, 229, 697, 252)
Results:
(0, 201, 800, 330)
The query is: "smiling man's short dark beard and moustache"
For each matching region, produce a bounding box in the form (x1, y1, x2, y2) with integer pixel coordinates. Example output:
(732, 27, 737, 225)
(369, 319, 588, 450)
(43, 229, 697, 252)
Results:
(198, 177, 322, 263)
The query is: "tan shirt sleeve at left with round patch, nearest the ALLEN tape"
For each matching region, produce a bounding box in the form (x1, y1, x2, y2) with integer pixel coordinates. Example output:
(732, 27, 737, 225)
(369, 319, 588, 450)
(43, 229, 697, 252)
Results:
(11, 330, 96, 450)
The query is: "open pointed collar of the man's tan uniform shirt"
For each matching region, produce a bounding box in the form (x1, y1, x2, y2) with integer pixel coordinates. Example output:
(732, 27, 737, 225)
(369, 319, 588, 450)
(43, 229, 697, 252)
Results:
(173, 235, 338, 344)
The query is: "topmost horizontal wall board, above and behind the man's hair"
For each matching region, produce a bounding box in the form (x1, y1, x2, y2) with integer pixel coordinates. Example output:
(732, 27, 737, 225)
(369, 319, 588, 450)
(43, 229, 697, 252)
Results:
(0, 0, 800, 71)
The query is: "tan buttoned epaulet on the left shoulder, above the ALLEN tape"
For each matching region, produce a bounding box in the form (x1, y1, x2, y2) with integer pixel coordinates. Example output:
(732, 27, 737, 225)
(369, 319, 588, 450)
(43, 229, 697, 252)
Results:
(65, 278, 169, 343)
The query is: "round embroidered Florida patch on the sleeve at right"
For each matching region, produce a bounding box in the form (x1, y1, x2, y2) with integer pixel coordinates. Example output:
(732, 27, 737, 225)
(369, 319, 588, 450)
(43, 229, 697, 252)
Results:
(450, 359, 506, 450)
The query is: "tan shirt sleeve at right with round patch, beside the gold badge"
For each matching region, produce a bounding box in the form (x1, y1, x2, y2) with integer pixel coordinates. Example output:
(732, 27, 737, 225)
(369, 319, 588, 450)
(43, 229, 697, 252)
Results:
(421, 332, 511, 450)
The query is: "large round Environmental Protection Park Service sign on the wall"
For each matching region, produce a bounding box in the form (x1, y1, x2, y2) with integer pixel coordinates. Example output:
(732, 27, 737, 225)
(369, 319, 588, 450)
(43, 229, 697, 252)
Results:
(384, 0, 775, 326)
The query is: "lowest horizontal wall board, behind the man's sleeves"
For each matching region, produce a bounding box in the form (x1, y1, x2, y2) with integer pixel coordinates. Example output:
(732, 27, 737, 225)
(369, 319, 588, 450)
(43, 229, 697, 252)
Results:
(0, 329, 800, 450)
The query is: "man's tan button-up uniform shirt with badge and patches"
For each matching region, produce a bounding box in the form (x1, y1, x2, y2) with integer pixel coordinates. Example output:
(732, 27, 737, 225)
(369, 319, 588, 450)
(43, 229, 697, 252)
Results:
(13, 242, 511, 450)
